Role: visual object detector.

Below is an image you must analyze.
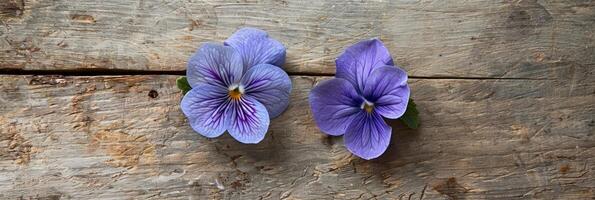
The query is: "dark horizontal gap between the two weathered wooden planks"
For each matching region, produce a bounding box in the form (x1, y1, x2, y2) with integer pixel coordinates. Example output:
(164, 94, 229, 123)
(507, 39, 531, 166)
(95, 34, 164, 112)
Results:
(0, 69, 550, 80)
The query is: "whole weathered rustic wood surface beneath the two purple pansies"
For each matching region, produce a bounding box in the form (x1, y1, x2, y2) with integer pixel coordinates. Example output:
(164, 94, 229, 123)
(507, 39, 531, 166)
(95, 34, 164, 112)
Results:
(0, 0, 595, 199)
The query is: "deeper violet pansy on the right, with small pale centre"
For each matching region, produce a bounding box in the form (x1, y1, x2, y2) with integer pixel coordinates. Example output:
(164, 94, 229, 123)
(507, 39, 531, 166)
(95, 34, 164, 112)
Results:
(309, 39, 409, 160)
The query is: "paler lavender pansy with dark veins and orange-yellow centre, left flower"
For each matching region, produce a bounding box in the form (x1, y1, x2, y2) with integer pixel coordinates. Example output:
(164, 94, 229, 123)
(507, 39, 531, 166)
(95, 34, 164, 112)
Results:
(181, 28, 291, 143)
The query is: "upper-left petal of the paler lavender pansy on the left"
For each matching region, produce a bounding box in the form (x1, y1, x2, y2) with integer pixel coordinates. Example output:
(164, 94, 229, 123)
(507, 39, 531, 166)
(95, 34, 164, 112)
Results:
(186, 43, 243, 88)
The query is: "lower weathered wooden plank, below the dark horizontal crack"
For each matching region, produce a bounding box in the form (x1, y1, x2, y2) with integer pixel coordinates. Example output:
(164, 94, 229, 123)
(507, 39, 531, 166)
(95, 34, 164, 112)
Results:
(0, 72, 595, 199)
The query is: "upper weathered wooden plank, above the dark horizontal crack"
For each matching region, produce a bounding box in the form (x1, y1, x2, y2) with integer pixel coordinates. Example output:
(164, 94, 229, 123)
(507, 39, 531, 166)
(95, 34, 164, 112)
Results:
(0, 0, 595, 79)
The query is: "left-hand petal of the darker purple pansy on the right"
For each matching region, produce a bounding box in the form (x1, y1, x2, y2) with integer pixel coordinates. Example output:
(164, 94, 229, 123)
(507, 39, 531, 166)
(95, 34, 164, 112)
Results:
(309, 78, 363, 136)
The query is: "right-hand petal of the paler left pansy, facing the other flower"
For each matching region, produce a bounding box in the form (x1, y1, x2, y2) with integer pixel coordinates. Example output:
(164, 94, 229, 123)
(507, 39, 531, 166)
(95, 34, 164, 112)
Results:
(242, 64, 291, 119)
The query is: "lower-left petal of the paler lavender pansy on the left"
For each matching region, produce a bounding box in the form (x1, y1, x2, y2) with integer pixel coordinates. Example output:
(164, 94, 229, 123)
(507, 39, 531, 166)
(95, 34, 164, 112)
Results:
(180, 84, 229, 138)
